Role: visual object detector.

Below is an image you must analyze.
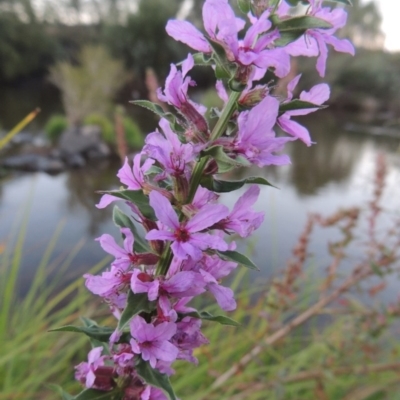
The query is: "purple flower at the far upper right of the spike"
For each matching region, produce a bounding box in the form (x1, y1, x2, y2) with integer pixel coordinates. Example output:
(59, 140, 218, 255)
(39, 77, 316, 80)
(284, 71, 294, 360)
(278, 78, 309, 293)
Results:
(285, 0, 354, 77)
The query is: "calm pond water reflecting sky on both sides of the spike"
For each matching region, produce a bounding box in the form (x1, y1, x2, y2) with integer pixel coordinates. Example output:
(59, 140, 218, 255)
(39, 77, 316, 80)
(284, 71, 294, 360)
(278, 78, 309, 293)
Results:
(0, 101, 400, 300)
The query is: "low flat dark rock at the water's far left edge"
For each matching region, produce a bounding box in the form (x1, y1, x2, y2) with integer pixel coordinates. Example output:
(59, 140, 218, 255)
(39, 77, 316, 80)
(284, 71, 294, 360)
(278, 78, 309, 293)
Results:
(1, 154, 65, 174)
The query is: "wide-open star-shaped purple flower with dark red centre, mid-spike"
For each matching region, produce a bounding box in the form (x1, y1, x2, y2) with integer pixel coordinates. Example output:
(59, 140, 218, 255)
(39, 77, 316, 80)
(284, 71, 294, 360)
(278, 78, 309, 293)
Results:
(146, 192, 229, 260)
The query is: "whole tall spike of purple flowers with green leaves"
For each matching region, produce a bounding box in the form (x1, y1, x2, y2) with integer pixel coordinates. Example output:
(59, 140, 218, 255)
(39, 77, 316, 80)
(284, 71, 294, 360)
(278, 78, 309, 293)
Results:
(60, 0, 353, 400)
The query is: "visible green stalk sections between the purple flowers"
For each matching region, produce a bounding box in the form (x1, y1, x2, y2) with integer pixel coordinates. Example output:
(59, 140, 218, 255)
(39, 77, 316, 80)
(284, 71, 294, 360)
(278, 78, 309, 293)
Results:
(156, 91, 241, 276)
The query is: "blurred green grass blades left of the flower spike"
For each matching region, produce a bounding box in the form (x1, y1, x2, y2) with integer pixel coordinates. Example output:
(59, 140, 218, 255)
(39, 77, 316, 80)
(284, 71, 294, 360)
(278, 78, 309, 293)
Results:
(0, 203, 111, 400)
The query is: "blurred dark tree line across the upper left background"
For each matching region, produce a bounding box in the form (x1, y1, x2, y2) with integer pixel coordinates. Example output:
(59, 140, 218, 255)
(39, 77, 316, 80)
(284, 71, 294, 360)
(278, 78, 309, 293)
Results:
(0, 0, 187, 82)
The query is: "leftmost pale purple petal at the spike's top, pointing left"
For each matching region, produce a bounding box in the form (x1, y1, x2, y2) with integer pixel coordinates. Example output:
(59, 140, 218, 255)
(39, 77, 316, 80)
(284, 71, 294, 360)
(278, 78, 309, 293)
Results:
(166, 20, 212, 53)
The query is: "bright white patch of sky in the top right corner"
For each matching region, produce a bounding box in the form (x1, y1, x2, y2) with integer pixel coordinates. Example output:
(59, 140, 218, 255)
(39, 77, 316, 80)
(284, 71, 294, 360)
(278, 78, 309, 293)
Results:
(376, 0, 400, 51)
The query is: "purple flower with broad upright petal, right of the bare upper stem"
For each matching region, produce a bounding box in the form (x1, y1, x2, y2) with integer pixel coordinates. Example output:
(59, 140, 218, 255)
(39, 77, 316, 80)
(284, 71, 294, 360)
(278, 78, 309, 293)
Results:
(228, 96, 294, 167)
